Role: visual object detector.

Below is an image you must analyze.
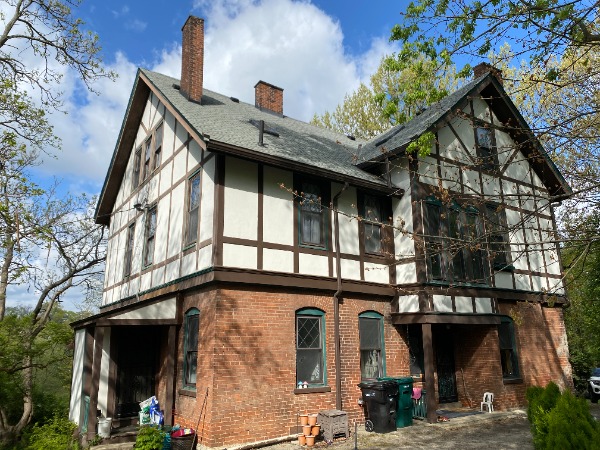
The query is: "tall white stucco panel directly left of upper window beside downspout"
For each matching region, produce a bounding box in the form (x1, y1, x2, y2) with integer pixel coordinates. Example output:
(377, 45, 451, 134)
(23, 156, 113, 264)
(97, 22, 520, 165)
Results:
(263, 166, 294, 245)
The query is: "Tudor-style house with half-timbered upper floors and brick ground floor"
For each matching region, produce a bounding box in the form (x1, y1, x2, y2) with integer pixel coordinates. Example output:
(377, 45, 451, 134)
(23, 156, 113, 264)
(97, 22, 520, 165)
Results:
(70, 17, 572, 447)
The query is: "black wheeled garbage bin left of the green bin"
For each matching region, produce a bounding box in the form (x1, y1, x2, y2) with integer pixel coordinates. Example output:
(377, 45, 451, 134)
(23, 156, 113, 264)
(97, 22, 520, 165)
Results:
(358, 381, 398, 433)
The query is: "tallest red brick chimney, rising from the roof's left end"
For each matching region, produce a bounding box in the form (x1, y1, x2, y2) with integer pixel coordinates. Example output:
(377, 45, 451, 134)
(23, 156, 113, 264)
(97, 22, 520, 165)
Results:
(181, 16, 204, 102)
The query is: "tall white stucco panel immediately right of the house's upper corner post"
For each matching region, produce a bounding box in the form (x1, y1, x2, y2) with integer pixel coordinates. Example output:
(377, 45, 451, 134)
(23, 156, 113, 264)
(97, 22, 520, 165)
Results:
(223, 157, 258, 243)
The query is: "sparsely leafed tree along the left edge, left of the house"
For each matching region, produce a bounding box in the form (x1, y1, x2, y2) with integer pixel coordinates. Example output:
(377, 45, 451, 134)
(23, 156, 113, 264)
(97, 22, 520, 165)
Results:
(0, 0, 114, 443)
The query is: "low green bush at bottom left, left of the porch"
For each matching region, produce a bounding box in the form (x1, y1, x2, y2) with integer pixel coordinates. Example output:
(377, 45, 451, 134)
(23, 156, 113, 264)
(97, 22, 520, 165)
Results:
(27, 416, 81, 450)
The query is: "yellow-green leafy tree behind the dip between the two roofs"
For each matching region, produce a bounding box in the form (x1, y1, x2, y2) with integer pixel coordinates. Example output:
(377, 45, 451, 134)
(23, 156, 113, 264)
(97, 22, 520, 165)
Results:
(311, 54, 456, 139)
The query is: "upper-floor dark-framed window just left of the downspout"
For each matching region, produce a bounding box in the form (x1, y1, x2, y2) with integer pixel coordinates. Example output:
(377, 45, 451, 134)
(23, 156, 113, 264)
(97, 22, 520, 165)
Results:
(300, 182, 325, 247)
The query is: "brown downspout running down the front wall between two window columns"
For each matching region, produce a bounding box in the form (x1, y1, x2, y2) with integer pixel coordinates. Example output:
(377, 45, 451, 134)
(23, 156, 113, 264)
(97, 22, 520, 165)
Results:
(332, 182, 348, 410)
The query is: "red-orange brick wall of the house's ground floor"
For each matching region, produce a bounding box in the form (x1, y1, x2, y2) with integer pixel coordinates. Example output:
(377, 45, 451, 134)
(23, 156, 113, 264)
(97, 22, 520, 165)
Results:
(169, 287, 568, 447)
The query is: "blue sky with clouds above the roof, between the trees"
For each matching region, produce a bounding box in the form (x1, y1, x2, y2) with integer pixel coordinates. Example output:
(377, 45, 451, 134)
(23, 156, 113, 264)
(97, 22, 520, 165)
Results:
(30, 0, 407, 194)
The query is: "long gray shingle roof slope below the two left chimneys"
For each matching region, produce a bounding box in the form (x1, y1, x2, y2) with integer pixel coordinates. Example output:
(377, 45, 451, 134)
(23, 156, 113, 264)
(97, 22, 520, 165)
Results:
(142, 70, 386, 186)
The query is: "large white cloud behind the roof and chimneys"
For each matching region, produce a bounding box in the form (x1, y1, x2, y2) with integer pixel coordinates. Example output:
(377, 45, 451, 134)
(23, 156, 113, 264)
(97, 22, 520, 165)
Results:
(35, 0, 393, 186)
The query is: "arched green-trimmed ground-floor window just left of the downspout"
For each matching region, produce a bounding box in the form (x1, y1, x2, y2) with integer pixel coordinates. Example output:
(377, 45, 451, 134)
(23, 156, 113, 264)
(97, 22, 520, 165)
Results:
(296, 308, 326, 386)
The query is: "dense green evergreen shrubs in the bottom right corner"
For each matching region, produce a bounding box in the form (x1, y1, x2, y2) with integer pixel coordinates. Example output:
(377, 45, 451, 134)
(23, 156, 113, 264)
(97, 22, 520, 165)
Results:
(526, 382, 600, 450)
